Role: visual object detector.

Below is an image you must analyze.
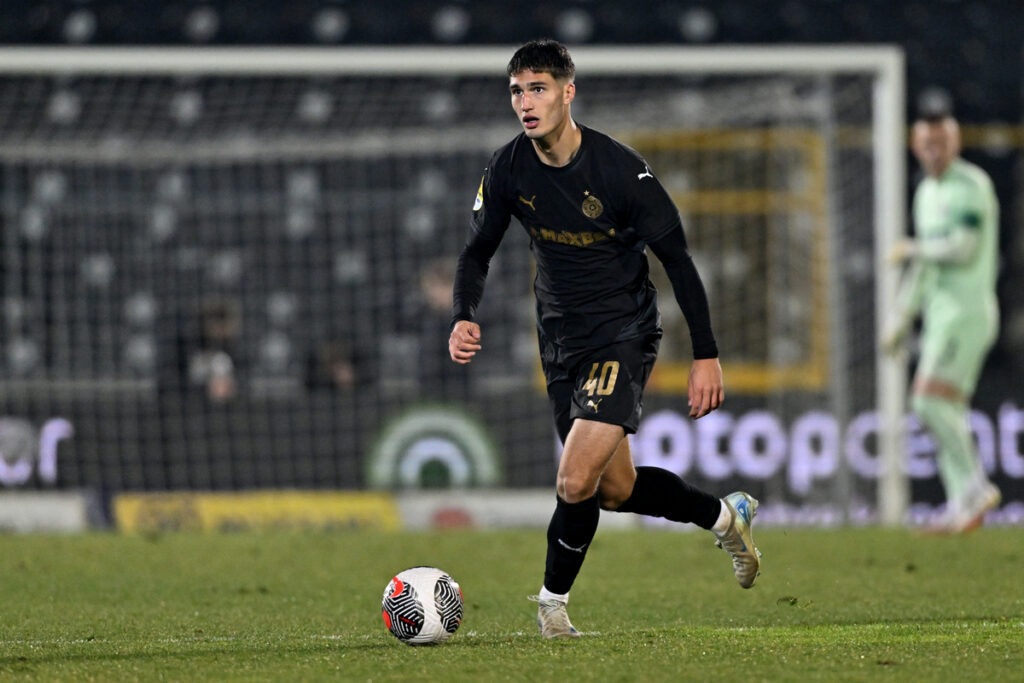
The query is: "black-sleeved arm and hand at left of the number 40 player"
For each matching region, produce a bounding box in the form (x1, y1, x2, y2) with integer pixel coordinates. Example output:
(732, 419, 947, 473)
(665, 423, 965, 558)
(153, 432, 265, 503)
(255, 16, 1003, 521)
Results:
(449, 152, 512, 365)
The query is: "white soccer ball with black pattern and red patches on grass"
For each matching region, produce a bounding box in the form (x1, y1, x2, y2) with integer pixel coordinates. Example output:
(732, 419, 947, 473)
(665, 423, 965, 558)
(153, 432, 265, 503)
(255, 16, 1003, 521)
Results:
(383, 567, 462, 645)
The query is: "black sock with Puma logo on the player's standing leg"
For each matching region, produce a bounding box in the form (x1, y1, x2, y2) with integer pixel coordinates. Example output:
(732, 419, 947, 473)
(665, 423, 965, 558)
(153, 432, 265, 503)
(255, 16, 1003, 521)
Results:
(544, 496, 601, 594)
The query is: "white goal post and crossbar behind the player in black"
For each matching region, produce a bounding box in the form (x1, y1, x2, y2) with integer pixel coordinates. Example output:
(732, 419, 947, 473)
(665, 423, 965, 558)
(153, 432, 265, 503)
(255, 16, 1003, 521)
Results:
(0, 45, 908, 525)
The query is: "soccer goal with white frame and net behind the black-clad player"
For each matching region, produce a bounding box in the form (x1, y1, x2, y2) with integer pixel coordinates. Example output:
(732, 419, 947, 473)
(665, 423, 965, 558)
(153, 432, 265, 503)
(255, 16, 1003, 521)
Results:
(0, 47, 906, 523)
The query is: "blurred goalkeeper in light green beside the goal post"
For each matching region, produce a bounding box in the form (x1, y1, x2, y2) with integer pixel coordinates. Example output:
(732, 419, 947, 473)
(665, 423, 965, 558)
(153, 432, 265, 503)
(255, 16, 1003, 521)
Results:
(882, 105, 999, 533)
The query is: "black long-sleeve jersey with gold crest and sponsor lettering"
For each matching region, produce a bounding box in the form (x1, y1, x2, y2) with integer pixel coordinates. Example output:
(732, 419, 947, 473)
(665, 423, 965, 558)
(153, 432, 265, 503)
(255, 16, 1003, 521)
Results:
(453, 126, 718, 358)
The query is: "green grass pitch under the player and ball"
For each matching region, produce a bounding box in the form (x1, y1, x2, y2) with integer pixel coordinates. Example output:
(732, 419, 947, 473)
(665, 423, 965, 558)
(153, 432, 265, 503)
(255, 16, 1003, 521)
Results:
(0, 528, 1024, 681)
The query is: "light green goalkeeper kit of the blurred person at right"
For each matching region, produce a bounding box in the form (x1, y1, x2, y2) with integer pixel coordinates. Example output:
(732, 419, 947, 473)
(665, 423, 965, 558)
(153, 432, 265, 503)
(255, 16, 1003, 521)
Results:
(900, 159, 999, 505)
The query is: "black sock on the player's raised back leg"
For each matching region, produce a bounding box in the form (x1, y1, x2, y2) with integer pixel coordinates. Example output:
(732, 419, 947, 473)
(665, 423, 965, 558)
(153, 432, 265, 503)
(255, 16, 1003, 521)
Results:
(614, 467, 722, 532)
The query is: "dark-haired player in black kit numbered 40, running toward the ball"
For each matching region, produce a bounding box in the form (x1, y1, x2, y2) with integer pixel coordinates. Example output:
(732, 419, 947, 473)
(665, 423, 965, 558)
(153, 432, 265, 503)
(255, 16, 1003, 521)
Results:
(449, 40, 760, 638)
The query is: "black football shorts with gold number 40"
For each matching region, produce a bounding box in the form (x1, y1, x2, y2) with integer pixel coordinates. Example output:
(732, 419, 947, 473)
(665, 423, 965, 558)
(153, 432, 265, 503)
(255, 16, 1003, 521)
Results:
(541, 333, 662, 443)
